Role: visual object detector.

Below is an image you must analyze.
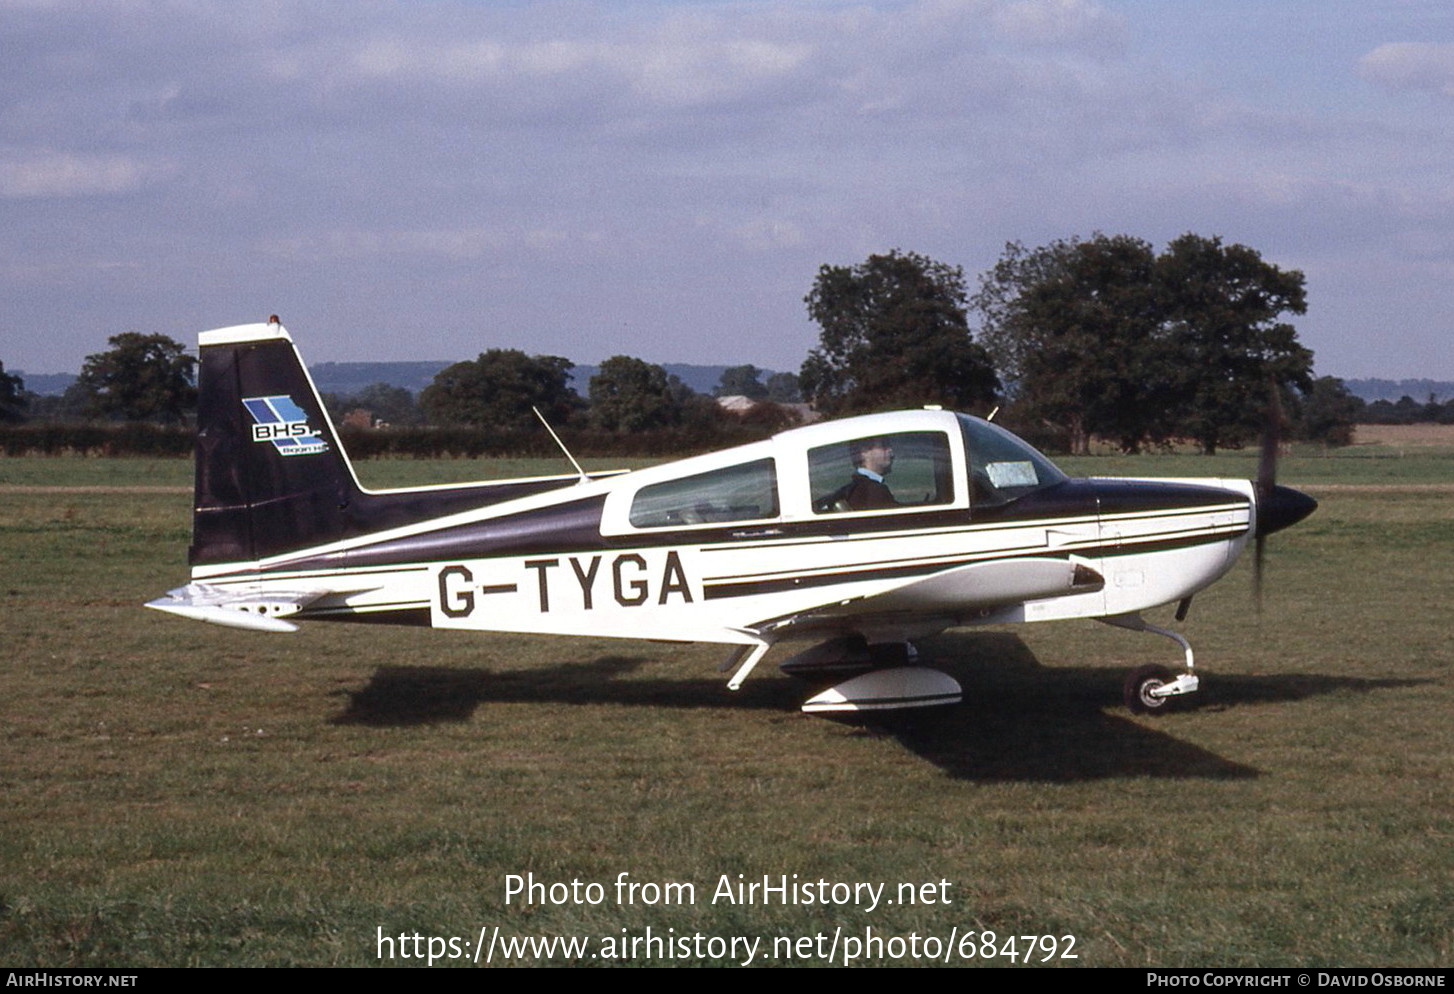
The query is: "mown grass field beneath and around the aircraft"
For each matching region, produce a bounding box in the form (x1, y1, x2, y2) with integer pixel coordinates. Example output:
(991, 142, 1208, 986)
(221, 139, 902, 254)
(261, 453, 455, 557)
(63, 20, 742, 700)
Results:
(0, 446, 1454, 966)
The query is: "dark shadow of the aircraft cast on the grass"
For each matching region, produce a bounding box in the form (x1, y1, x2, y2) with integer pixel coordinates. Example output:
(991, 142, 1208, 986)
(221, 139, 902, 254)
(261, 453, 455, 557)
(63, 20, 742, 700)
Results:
(333, 632, 1418, 782)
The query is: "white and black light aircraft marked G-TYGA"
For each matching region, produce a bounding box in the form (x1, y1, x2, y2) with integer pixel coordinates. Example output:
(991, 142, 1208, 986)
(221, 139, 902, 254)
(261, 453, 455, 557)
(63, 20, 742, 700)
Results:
(147, 318, 1317, 718)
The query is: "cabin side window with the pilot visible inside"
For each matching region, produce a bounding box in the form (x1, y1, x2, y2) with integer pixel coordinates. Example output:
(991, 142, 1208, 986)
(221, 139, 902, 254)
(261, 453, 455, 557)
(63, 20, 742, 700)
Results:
(808, 432, 954, 514)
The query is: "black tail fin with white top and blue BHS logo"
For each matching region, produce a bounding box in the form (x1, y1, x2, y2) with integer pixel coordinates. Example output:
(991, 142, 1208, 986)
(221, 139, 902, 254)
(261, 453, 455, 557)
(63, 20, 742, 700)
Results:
(190, 318, 361, 565)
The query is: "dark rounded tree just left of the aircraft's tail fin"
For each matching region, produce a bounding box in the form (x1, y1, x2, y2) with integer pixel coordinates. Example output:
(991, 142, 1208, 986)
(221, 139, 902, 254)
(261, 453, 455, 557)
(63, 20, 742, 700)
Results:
(76, 331, 196, 424)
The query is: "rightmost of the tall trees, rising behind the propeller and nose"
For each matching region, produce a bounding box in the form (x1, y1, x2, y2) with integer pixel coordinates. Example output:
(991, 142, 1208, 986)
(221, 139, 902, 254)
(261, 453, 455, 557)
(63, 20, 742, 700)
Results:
(1156, 234, 1313, 455)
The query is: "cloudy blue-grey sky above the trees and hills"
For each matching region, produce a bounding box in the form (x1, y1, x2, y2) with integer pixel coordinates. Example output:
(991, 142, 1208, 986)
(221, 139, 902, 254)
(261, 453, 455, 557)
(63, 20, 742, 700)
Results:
(0, 0, 1454, 379)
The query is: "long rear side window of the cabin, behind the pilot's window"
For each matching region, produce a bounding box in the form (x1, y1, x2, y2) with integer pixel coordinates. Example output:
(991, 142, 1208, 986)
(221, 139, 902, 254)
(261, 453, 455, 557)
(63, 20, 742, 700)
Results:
(631, 459, 778, 528)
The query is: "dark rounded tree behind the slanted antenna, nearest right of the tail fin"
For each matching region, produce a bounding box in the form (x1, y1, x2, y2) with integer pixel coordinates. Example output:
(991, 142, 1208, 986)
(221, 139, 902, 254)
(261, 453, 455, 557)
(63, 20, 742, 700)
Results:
(419, 349, 580, 430)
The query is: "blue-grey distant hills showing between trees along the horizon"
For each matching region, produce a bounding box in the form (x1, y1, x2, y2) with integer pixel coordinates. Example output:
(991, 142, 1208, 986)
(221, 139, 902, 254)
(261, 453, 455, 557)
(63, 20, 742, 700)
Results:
(15, 360, 1454, 404)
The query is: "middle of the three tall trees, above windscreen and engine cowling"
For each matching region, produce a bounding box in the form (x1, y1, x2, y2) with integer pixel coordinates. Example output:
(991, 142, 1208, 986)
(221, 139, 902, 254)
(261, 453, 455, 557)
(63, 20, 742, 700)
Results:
(974, 234, 1170, 453)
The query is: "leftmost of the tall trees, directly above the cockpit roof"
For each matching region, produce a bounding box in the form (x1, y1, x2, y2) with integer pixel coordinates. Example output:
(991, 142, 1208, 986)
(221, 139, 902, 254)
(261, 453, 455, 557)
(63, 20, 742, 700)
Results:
(798, 250, 999, 414)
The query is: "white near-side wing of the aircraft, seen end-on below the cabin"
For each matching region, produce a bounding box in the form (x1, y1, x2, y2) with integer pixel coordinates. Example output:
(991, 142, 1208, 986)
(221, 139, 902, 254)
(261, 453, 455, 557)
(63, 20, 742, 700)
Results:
(752, 557, 1105, 634)
